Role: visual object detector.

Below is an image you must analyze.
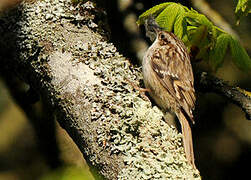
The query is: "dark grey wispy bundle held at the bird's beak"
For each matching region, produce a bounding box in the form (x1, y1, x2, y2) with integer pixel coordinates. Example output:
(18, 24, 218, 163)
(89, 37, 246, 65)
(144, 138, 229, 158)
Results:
(145, 16, 162, 41)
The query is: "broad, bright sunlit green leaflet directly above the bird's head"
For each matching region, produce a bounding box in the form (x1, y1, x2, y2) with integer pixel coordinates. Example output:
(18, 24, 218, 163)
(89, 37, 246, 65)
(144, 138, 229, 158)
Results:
(156, 3, 185, 32)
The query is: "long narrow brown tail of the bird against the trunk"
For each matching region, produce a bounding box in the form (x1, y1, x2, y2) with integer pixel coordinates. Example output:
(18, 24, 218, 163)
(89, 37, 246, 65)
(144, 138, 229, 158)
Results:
(176, 111, 196, 168)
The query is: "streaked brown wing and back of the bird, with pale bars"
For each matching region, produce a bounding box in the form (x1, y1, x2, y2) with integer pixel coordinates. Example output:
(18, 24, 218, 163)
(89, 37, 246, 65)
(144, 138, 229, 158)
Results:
(151, 45, 195, 121)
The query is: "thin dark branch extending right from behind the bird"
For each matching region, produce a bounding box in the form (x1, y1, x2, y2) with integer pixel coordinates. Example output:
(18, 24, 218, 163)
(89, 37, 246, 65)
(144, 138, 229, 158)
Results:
(196, 72, 251, 120)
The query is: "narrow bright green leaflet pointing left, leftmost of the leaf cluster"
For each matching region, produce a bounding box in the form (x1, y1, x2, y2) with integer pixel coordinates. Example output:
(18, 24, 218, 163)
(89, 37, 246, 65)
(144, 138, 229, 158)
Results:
(136, 2, 171, 25)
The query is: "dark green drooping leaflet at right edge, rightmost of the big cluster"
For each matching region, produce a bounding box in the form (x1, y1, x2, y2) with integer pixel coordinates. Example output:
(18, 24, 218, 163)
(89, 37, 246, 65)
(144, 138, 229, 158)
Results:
(230, 37, 251, 71)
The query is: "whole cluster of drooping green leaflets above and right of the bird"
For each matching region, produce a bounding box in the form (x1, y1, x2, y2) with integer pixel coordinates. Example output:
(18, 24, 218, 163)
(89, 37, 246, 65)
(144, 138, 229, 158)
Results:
(137, 2, 251, 71)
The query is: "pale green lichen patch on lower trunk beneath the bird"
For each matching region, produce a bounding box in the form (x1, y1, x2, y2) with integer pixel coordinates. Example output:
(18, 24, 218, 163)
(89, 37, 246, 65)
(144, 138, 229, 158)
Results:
(112, 96, 200, 179)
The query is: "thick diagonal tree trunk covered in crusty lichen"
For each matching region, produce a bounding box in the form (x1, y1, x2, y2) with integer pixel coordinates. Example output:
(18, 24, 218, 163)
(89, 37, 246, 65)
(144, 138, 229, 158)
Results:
(0, 0, 200, 179)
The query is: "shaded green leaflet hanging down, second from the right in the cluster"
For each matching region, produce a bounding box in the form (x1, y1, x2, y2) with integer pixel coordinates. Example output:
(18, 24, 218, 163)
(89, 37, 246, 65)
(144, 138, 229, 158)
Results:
(209, 33, 232, 71)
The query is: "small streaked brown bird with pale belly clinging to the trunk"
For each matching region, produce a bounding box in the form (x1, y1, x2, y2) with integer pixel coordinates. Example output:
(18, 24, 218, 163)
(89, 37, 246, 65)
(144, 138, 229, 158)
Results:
(142, 17, 195, 167)
